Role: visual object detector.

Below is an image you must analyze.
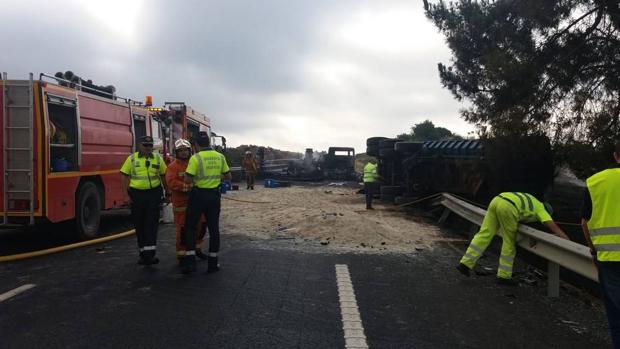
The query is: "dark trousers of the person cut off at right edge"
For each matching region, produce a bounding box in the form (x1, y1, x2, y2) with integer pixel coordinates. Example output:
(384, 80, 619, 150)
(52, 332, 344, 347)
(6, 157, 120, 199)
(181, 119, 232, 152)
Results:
(598, 262, 620, 349)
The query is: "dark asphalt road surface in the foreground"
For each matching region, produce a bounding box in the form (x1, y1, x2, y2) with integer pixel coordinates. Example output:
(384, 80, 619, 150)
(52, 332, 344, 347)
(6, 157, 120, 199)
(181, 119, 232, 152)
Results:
(0, 225, 611, 348)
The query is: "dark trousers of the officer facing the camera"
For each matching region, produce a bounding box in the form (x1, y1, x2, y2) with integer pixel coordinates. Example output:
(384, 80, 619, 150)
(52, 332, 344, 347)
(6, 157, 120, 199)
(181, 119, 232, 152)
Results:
(129, 187, 162, 260)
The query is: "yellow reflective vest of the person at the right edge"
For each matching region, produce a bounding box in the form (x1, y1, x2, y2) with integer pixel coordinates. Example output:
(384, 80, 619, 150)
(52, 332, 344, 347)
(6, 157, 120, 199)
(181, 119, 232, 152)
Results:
(586, 168, 620, 262)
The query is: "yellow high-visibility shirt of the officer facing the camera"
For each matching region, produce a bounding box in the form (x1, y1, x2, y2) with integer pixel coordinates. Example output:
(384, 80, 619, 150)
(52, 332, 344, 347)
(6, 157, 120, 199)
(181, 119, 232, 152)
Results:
(121, 152, 166, 190)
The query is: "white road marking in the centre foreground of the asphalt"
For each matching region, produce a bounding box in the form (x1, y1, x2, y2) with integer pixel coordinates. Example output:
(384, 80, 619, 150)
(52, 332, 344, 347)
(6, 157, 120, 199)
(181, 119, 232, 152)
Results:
(336, 264, 368, 349)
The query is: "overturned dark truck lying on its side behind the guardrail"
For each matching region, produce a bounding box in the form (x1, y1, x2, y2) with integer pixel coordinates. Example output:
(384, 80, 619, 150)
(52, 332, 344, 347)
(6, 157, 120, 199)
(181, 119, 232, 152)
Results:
(366, 136, 554, 203)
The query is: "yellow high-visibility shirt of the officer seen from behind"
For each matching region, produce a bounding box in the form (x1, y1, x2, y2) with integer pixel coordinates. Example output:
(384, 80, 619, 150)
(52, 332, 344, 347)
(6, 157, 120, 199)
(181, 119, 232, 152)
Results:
(185, 149, 230, 189)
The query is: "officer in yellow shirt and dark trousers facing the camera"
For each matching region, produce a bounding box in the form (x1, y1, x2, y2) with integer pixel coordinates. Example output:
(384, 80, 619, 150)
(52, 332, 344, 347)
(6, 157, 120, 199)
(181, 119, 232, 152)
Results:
(121, 136, 166, 265)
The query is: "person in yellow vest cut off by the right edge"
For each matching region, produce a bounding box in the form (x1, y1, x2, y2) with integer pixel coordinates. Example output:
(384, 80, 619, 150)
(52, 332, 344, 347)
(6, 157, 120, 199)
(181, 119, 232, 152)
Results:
(581, 140, 620, 348)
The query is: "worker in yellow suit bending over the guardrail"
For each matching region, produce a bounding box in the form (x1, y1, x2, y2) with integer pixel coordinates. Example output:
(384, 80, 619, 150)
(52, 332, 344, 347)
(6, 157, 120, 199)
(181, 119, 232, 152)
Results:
(456, 192, 568, 286)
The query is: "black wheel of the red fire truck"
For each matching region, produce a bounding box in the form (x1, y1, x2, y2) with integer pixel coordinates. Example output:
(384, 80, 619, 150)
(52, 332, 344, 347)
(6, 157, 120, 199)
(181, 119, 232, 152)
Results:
(75, 182, 101, 240)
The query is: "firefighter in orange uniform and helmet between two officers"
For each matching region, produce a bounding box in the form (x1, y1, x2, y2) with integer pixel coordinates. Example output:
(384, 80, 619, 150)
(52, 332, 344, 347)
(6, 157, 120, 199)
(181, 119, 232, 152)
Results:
(166, 139, 207, 260)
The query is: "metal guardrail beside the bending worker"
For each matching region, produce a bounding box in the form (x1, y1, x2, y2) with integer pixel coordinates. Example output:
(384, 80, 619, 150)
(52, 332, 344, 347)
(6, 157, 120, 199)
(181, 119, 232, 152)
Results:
(439, 193, 598, 297)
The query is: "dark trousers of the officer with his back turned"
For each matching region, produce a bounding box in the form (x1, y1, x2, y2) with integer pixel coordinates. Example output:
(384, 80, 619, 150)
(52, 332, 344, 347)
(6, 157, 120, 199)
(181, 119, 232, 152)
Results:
(183, 188, 221, 253)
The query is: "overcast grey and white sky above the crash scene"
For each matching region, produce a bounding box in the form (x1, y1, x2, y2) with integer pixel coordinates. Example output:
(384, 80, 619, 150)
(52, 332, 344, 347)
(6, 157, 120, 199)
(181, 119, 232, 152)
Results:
(0, 0, 473, 152)
